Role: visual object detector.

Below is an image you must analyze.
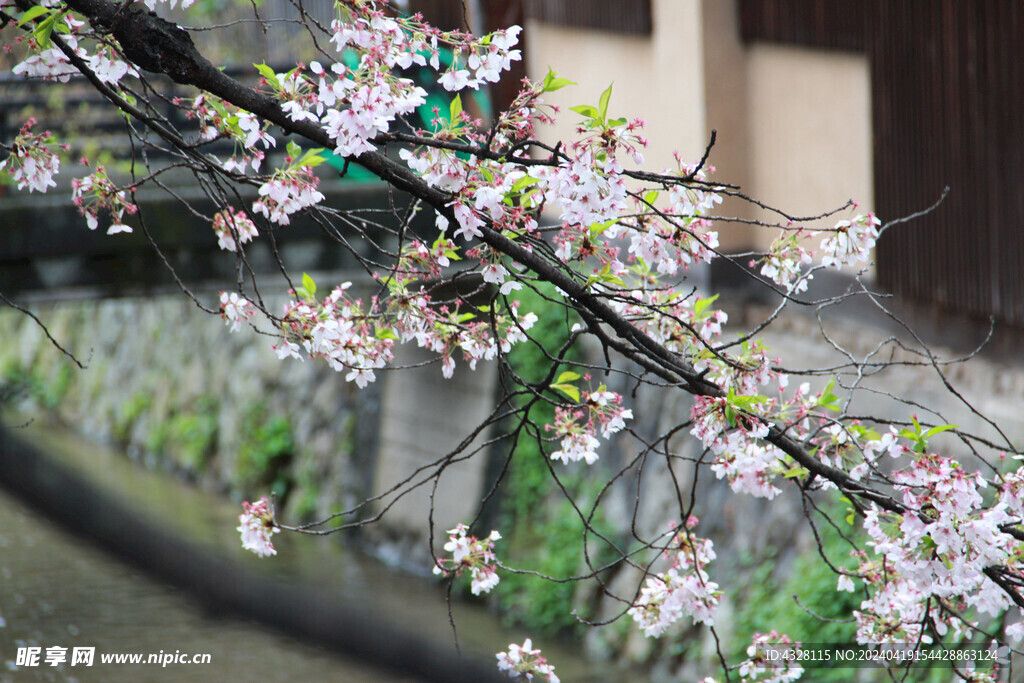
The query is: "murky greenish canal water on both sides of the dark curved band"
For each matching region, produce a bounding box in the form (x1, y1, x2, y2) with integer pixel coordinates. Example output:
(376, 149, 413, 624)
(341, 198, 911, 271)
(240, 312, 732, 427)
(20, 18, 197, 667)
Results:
(0, 424, 600, 681)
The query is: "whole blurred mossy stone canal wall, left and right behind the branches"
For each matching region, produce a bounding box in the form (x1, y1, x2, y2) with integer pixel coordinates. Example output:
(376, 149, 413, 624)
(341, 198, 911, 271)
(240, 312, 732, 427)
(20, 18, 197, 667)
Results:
(6, 275, 1024, 680)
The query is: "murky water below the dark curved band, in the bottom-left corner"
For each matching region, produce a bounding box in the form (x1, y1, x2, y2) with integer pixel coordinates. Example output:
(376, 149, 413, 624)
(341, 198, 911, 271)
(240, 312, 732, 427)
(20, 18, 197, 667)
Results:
(0, 495, 409, 682)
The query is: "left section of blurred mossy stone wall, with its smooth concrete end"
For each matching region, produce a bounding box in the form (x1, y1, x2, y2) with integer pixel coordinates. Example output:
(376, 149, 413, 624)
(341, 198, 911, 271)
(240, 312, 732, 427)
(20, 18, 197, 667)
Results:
(0, 284, 494, 553)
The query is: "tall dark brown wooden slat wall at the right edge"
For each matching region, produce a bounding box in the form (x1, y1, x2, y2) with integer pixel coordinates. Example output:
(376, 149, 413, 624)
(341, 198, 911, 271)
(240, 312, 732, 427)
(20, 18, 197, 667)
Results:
(868, 0, 1024, 326)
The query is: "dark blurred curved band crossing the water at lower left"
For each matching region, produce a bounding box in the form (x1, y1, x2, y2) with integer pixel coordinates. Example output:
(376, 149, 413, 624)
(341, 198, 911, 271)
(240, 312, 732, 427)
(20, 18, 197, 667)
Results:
(0, 429, 508, 682)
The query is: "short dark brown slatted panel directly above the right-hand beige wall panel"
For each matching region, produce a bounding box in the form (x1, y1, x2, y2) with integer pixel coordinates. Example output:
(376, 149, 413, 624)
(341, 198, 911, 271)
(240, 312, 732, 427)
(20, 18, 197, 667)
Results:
(739, 0, 868, 50)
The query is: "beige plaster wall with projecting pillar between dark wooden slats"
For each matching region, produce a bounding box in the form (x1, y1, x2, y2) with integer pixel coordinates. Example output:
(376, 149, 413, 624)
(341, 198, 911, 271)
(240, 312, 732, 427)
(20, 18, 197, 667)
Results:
(526, 0, 873, 255)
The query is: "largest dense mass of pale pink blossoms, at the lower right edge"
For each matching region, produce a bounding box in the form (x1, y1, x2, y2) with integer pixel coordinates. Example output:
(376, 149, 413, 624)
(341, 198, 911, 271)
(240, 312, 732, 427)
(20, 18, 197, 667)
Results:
(841, 453, 1024, 643)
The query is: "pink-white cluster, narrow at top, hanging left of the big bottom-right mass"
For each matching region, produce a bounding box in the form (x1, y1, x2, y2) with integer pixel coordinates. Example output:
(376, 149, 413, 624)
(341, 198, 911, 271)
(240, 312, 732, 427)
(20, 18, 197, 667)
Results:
(627, 516, 721, 638)
